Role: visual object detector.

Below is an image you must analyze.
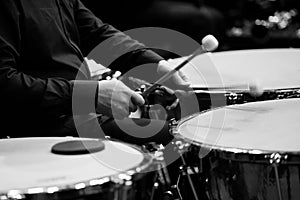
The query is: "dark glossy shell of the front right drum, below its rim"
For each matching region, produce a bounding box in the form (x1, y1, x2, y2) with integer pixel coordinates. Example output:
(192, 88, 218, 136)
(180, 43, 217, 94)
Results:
(179, 144, 300, 200)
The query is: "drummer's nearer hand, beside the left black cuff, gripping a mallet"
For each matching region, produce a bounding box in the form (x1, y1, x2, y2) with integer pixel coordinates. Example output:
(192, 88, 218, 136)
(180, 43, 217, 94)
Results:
(96, 80, 145, 119)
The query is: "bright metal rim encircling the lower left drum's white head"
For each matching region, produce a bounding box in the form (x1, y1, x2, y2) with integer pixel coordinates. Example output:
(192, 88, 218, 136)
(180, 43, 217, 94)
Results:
(0, 136, 154, 200)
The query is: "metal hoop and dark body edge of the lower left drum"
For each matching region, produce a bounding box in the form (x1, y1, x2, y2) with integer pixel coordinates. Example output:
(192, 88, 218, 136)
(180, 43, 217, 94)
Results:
(0, 139, 156, 200)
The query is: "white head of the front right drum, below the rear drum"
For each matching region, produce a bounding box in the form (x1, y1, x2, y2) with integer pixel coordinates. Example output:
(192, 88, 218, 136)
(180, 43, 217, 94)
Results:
(177, 99, 300, 153)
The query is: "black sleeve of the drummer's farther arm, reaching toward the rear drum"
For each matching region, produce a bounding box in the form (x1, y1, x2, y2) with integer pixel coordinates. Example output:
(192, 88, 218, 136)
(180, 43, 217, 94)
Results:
(74, 0, 163, 69)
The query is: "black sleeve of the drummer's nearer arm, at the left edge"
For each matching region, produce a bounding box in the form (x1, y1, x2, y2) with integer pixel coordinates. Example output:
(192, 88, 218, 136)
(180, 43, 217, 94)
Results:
(0, 0, 97, 117)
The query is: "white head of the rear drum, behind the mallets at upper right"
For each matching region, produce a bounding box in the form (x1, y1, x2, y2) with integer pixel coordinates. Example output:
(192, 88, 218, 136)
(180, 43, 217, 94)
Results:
(176, 49, 300, 90)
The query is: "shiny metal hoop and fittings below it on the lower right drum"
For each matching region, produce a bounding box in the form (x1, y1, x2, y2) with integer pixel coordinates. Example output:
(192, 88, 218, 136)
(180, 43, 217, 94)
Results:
(171, 105, 300, 164)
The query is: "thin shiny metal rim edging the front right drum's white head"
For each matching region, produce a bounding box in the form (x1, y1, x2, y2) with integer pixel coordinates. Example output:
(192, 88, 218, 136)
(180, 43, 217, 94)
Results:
(171, 99, 300, 156)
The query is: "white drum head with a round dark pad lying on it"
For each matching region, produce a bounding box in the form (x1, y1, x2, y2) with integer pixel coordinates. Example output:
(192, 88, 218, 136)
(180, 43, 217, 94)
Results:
(0, 137, 152, 194)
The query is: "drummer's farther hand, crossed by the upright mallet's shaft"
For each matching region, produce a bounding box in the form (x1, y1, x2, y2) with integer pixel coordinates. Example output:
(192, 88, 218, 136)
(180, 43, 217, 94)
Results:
(157, 60, 190, 90)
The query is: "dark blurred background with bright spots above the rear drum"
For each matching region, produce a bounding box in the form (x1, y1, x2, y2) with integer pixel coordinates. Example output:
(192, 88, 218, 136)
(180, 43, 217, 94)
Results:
(82, 0, 300, 51)
